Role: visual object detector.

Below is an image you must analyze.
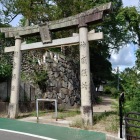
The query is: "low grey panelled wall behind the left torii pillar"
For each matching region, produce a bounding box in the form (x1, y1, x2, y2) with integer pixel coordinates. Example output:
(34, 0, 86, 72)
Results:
(0, 81, 45, 113)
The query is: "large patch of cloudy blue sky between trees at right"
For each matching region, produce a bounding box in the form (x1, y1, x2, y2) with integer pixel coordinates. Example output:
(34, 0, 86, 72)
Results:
(110, 44, 136, 70)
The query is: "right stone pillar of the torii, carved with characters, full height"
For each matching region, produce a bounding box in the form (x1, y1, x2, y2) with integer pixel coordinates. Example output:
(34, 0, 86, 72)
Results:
(79, 24, 93, 126)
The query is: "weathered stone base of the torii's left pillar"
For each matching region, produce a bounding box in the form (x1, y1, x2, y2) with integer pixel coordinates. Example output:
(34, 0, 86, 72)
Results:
(8, 103, 18, 119)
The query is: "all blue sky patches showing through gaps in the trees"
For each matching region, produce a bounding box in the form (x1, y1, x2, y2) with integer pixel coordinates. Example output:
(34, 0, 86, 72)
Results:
(1, 0, 139, 71)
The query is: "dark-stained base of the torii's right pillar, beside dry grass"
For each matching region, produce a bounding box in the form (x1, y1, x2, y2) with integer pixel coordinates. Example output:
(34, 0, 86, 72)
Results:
(81, 106, 93, 126)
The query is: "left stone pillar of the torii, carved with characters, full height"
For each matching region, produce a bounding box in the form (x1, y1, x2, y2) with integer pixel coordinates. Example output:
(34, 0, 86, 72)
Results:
(8, 36, 21, 119)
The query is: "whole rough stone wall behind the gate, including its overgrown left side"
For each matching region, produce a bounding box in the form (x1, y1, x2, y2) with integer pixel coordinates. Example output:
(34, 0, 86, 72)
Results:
(22, 50, 97, 108)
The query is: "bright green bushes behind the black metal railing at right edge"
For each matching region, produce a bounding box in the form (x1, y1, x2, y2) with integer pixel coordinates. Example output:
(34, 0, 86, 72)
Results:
(121, 67, 140, 112)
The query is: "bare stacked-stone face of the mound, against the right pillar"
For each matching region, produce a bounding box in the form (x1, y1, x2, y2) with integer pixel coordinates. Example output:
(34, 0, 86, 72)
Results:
(42, 51, 80, 107)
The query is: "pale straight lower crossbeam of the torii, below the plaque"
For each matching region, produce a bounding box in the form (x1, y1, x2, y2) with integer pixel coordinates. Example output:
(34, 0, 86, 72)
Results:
(4, 30, 103, 52)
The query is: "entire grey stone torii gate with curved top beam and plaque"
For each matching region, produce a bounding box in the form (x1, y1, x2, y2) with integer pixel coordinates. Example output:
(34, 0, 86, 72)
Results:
(0, 3, 111, 125)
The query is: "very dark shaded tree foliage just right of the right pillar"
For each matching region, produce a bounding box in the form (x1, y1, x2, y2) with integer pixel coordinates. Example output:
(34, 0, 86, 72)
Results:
(90, 43, 112, 87)
